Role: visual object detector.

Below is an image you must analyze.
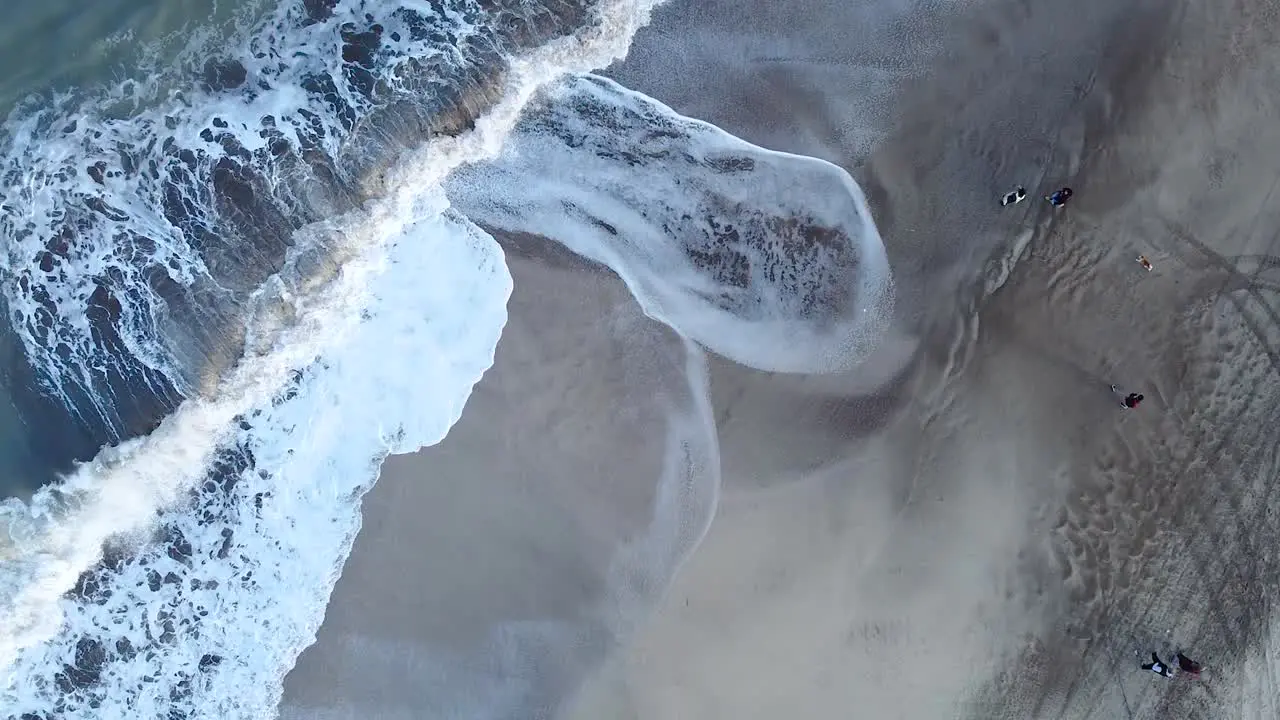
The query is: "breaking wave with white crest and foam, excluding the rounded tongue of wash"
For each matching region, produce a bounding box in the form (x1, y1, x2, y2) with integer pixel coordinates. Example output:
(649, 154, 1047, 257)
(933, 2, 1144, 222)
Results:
(0, 0, 675, 717)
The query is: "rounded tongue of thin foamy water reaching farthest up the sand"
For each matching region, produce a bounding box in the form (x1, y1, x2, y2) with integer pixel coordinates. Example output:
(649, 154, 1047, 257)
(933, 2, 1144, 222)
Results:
(448, 76, 892, 373)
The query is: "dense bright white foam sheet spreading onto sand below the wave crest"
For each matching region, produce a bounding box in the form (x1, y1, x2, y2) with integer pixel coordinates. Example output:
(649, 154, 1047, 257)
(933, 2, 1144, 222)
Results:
(5, 203, 509, 717)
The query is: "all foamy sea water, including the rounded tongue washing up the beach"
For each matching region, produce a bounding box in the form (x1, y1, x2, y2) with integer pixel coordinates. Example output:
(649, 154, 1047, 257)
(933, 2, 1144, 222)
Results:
(0, 0, 891, 720)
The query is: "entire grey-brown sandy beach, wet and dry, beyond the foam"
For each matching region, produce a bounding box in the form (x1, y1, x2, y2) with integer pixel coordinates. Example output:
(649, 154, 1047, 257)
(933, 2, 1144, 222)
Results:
(285, 0, 1280, 720)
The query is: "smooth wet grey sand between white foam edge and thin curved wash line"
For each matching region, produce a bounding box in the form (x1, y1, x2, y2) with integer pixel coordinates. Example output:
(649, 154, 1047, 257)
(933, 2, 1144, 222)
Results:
(282, 238, 713, 717)
